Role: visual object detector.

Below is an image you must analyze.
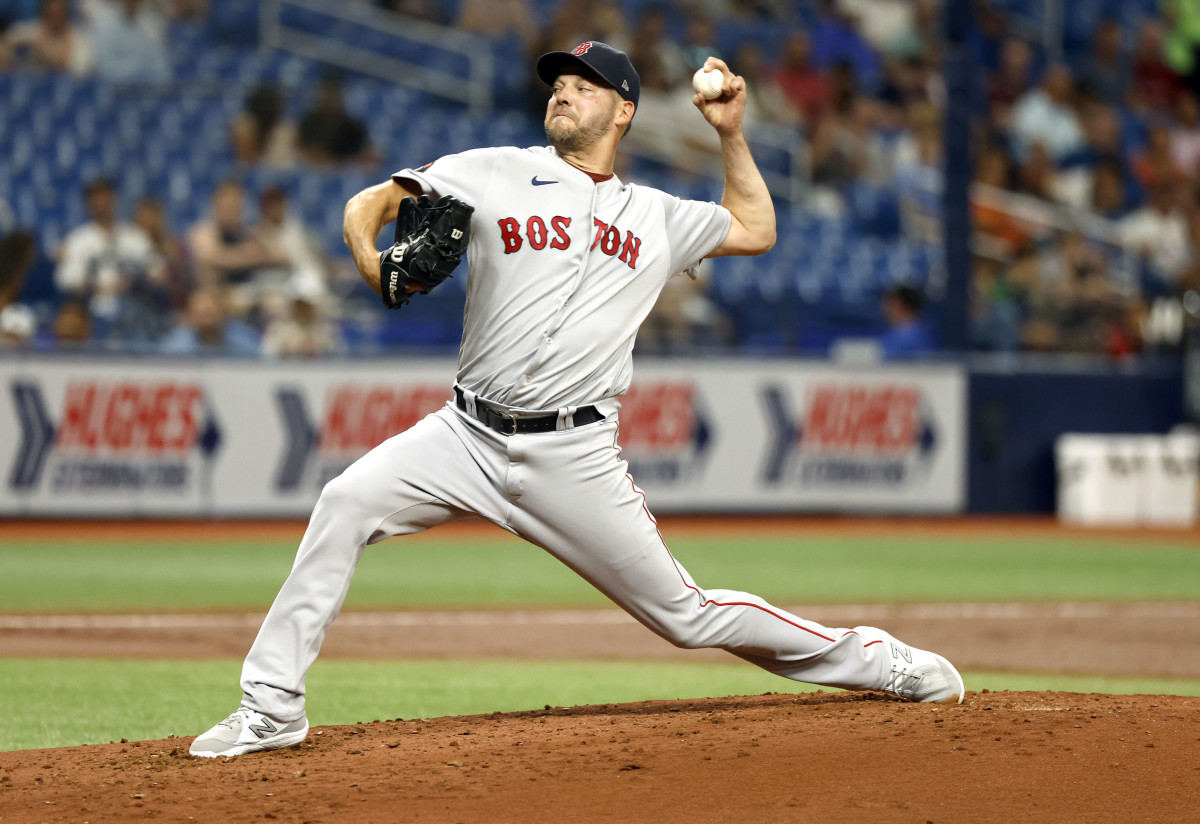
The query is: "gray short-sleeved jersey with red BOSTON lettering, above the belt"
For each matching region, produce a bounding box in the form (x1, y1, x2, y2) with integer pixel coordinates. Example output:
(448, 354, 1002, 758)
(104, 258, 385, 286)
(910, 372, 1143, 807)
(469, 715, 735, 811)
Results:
(394, 148, 732, 411)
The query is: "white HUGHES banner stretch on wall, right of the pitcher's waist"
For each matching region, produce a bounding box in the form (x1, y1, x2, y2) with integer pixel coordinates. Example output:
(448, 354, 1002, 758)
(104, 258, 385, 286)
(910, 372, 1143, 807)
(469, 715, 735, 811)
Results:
(620, 361, 966, 512)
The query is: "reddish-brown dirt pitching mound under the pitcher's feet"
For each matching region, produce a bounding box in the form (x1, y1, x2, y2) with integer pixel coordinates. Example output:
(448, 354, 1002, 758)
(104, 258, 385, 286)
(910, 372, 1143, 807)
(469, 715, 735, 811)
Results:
(0, 692, 1200, 824)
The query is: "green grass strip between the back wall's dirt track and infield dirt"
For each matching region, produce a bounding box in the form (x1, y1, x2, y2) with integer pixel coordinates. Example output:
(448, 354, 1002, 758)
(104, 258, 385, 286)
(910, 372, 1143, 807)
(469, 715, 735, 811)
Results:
(0, 530, 1200, 612)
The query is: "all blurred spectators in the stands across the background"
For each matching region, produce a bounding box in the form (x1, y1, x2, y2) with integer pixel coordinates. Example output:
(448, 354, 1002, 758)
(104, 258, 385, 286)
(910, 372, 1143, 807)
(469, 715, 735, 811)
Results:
(0, 0, 1200, 357)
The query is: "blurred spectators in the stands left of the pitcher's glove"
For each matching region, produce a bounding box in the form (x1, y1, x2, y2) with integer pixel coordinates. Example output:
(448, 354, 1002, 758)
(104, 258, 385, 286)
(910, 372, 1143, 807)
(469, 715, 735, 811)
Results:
(0, 0, 376, 357)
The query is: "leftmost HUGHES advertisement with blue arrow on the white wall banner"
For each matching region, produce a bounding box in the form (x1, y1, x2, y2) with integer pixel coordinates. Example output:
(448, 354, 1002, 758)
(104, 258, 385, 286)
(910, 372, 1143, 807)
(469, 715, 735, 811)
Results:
(0, 362, 224, 515)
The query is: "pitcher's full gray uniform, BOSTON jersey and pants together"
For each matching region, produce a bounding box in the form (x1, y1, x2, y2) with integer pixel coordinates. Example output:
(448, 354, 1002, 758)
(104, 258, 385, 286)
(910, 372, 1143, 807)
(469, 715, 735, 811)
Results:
(234, 143, 950, 722)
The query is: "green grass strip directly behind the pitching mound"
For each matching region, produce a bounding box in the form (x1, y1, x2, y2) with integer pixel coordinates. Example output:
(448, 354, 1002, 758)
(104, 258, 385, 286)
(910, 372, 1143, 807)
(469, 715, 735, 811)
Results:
(0, 658, 1200, 751)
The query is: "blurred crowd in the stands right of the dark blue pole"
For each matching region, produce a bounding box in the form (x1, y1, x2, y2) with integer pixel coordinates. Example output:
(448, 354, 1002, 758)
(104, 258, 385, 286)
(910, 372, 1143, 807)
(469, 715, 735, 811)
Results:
(972, 8, 1200, 357)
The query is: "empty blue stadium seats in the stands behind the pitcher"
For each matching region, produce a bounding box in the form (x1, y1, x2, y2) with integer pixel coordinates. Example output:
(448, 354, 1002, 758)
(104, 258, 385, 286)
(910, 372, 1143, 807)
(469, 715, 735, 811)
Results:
(0, 15, 993, 351)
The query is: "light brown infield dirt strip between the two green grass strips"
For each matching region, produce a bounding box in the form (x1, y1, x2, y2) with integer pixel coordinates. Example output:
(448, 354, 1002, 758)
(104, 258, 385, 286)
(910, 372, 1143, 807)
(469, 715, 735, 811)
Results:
(7, 602, 1200, 678)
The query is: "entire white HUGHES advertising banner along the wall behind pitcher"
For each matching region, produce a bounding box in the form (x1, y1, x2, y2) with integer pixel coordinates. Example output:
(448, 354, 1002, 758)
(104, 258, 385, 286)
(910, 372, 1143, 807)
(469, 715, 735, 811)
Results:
(0, 357, 966, 517)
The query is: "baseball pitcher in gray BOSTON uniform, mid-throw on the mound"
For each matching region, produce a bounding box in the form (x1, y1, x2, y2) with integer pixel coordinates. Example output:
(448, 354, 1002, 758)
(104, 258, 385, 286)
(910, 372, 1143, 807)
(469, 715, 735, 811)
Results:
(191, 41, 964, 757)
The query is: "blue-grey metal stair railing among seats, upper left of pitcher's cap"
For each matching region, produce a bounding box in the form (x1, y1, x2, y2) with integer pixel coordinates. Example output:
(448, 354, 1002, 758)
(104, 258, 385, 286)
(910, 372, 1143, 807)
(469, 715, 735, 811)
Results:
(259, 0, 494, 114)
